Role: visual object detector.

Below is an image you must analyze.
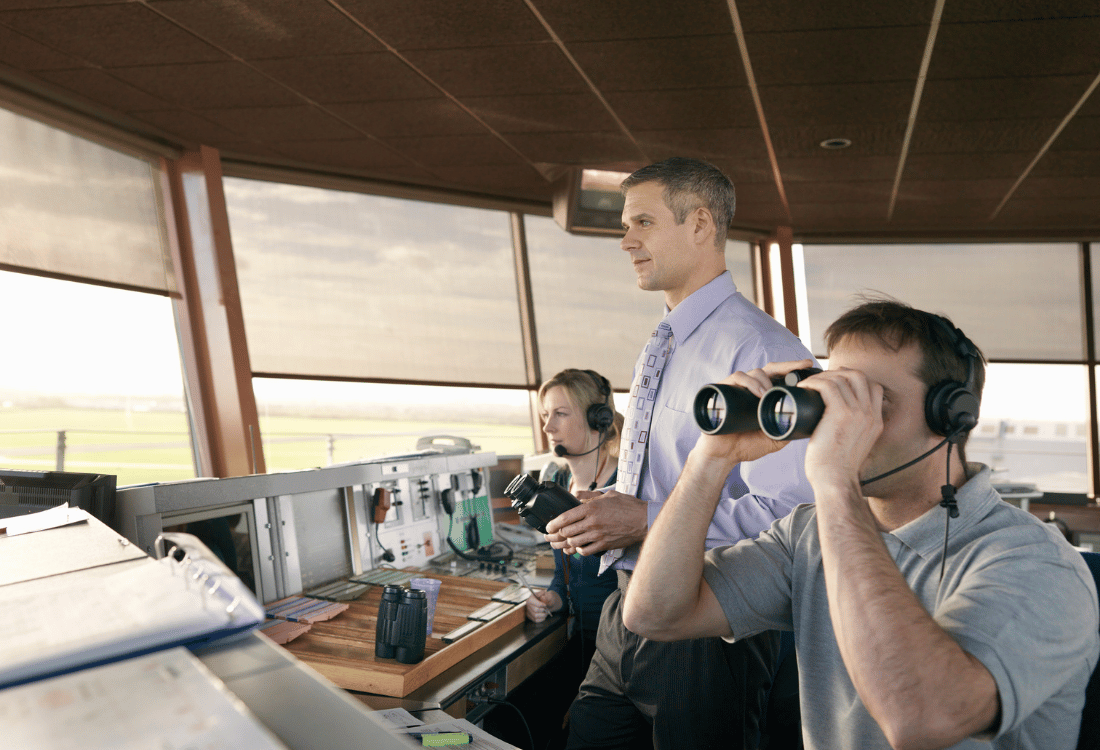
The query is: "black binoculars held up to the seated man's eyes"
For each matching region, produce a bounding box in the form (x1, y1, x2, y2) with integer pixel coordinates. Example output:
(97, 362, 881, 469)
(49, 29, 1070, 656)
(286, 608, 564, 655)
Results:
(694, 367, 825, 440)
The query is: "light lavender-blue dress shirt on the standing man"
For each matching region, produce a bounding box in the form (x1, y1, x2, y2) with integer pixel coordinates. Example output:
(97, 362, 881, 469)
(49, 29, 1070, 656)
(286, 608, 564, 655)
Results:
(616, 273, 814, 569)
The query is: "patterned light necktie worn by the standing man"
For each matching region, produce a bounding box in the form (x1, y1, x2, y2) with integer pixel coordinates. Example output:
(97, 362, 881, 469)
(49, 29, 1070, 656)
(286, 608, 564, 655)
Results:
(600, 320, 672, 573)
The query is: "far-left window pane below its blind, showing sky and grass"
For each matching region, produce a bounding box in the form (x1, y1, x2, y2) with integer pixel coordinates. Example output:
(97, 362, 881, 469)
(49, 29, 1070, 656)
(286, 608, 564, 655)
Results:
(0, 272, 195, 485)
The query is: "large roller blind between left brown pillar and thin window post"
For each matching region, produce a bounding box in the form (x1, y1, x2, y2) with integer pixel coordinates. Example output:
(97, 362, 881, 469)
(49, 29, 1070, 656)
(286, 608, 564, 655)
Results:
(224, 178, 525, 385)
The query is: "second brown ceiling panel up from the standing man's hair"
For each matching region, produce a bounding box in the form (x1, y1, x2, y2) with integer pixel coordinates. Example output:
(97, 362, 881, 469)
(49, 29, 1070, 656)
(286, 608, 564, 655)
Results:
(606, 86, 758, 130)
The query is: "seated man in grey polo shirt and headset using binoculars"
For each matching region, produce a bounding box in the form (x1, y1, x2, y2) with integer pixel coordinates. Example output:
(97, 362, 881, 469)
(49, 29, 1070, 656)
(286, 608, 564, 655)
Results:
(624, 300, 1100, 750)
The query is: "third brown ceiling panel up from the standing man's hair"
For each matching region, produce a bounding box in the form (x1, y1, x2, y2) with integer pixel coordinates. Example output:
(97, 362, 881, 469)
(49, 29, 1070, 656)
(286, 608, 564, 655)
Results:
(569, 34, 747, 93)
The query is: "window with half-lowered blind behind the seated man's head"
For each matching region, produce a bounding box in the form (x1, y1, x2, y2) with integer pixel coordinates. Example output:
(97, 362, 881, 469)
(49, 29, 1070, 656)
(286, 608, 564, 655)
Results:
(803, 243, 1089, 493)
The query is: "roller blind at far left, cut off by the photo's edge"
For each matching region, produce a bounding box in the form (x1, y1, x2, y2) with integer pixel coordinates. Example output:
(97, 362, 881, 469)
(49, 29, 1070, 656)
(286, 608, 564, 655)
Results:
(0, 109, 175, 291)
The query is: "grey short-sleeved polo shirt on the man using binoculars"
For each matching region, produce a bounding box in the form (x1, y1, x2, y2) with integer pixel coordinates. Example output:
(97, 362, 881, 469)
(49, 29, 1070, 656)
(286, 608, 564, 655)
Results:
(703, 464, 1100, 750)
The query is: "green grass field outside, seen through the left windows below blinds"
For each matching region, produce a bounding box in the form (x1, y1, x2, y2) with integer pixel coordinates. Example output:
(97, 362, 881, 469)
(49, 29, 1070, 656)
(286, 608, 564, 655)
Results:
(0, 408, 534, 486)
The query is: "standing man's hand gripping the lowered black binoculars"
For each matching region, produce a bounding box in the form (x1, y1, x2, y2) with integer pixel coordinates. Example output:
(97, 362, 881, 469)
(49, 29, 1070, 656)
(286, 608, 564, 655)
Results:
(547, 489, 649, 555)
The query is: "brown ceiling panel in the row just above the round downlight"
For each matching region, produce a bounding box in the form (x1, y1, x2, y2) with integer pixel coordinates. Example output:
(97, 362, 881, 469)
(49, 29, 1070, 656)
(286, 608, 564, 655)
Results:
(760, 80, 913, 126)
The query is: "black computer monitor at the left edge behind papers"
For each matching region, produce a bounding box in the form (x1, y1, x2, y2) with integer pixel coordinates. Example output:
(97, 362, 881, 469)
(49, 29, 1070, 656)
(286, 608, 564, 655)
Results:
(0, 468, 118, 530)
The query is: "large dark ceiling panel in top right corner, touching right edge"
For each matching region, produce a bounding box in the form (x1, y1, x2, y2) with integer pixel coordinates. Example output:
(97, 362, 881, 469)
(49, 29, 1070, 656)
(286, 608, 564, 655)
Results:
(928, 18, 1100, 78)
